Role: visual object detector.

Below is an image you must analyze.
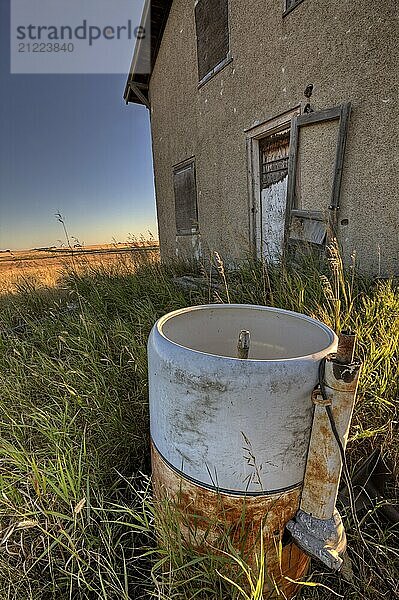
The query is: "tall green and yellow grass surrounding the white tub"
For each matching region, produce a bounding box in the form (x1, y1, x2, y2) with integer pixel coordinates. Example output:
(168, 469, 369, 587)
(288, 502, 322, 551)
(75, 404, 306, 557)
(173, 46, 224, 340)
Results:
(0, 246, 399, 600)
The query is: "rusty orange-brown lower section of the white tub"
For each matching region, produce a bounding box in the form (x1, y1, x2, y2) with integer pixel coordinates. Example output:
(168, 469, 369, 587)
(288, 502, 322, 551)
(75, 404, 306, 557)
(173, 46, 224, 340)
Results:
(151, 446, 310, 598)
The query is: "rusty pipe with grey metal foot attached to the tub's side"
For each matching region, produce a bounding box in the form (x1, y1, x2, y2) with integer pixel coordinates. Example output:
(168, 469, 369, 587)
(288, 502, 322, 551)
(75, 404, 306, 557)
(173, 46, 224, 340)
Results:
(287, 333, 361, 570)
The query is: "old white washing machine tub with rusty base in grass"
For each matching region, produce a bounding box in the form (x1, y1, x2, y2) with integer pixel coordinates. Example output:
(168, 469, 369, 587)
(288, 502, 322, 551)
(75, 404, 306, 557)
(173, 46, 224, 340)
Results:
(148, 304, 337, 598)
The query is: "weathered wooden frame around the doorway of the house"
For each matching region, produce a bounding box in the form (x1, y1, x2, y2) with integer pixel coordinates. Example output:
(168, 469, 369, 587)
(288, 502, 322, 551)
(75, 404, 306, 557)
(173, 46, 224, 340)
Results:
(244, 104, 301, 258)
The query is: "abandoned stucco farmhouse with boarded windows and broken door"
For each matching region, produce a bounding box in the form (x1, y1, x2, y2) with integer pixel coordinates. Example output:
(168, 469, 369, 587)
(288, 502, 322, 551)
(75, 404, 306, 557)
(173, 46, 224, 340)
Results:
(125, 0, 399, 276)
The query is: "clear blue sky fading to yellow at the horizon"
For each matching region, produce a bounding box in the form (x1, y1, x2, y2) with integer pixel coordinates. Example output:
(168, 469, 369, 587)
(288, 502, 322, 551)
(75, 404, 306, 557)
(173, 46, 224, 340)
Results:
(0, 0, 156, 249)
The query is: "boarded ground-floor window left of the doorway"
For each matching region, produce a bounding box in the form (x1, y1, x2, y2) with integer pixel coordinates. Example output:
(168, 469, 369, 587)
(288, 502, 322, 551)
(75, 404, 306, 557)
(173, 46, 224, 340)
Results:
(173, 161, 198, 235)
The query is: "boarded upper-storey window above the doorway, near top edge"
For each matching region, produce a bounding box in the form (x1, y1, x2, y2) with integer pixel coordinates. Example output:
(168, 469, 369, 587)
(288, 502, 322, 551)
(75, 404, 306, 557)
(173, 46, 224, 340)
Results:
(195, 0, 229, 81)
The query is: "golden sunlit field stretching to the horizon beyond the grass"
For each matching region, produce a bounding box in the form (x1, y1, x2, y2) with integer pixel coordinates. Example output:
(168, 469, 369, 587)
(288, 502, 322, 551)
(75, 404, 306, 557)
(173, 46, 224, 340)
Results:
(0, 240, 158, 294)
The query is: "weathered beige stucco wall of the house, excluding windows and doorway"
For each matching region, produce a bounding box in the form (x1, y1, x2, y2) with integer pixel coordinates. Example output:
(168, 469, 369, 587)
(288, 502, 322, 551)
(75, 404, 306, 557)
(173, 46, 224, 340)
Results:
(150, 0, 399, 275)
